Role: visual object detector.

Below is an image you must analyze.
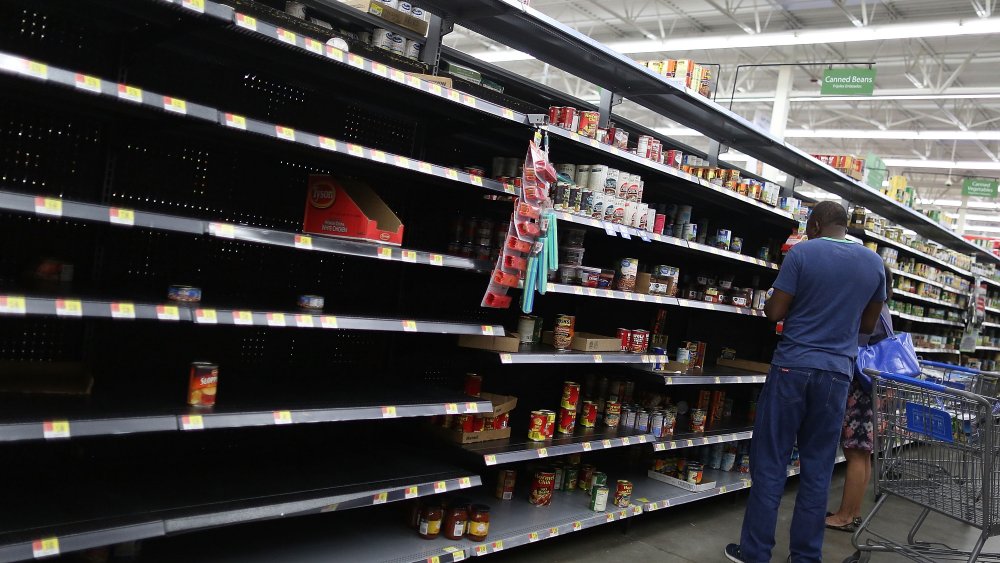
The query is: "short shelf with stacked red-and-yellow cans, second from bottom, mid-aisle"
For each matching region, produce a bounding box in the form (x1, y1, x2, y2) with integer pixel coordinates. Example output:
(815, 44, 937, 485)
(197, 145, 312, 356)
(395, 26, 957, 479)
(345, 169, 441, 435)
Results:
(462, 427, 656, 465)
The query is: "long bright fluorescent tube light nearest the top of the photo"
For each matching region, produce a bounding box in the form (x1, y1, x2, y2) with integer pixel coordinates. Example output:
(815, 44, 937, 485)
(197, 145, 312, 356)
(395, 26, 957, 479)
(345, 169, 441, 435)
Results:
(469, 17, 1000, 63)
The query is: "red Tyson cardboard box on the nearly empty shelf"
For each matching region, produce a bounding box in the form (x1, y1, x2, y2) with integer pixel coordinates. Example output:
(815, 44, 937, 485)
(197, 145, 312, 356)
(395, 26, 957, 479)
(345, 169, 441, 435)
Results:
(302, 174, 403, 246)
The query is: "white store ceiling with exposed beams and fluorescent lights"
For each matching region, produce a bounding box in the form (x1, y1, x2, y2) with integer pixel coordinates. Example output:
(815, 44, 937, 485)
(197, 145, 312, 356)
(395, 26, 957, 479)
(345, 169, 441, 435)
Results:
(446, 0, 1000, 235)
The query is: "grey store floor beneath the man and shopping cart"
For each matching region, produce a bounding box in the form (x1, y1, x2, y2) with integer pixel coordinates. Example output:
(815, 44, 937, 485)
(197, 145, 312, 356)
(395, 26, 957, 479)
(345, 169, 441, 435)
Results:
(490, 467, 1000, 563)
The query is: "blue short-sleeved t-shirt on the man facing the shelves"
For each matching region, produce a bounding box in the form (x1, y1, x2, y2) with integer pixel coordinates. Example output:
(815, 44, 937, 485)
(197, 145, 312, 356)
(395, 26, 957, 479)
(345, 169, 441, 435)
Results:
(772, 238, 885, 376)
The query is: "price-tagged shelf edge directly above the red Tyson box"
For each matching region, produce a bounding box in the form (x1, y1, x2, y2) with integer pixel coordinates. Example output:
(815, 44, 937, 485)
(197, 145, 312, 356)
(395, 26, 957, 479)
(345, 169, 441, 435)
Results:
(0, 49, 516, 194)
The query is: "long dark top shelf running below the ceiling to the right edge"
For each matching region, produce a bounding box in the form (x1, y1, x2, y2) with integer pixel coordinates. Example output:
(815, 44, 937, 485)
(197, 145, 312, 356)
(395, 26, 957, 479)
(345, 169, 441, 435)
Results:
(424, 0, 1000, 262)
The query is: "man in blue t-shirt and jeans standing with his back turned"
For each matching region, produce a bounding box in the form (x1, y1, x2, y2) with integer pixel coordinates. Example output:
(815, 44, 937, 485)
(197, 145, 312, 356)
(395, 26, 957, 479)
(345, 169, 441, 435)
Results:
(726, 201, 886, 563)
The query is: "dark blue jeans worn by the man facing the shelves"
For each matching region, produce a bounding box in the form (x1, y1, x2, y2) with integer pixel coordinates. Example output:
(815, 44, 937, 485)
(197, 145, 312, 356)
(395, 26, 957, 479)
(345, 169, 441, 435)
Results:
(740, 365, 851, 563)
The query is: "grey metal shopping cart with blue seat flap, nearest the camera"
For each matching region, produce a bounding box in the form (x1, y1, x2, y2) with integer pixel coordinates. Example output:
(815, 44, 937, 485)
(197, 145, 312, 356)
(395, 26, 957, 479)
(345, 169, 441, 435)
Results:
(844, 370, 1000, 563)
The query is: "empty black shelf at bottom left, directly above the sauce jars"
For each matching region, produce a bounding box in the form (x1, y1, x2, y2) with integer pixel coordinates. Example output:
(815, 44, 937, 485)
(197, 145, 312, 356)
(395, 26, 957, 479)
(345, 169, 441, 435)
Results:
(0, 452, 482, 562)
